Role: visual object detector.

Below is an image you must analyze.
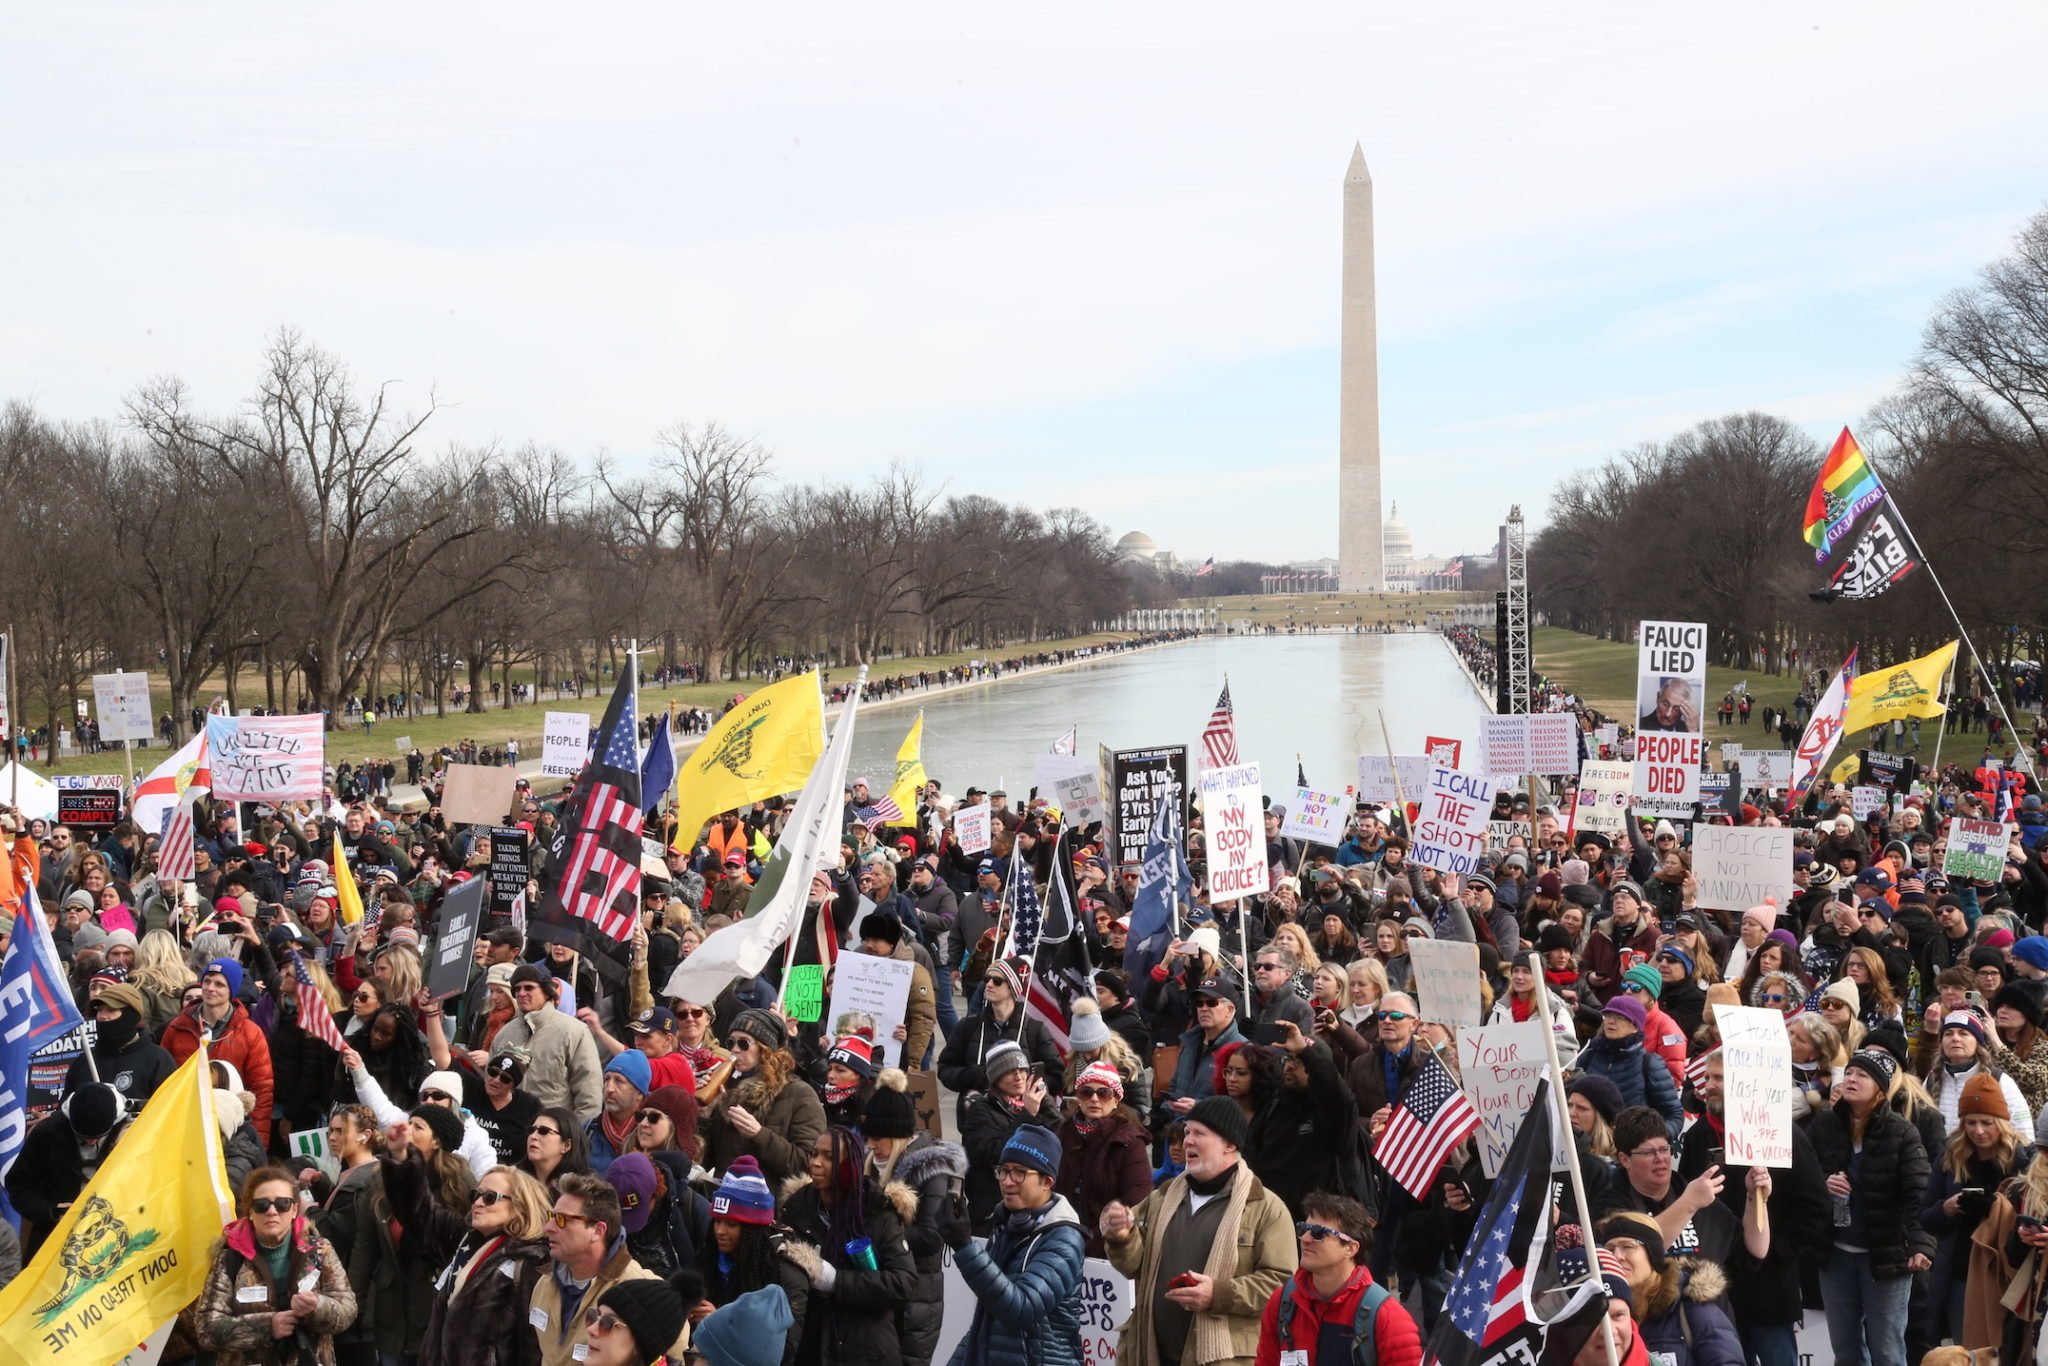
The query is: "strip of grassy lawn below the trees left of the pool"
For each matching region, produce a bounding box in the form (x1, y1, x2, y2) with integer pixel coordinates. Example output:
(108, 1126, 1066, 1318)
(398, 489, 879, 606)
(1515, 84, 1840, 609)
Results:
(25, 631, 1135, 776)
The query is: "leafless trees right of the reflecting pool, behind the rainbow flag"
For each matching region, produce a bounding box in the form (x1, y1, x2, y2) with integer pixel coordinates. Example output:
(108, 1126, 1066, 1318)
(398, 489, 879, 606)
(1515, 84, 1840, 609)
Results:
(1530, 213, 2048, 684)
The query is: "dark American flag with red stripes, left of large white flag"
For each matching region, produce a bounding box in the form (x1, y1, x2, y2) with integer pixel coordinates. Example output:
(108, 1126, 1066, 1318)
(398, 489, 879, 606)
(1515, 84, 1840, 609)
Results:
(528, 666, 647, 981)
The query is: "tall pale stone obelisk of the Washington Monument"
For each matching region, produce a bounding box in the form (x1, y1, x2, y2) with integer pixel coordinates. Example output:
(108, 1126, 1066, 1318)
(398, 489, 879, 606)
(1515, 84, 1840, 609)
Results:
(1337, 145, 1386, 592)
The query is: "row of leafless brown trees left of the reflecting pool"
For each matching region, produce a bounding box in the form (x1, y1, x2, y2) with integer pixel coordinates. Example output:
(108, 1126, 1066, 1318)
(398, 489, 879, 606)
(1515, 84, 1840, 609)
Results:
(0, 332, 1128, 735)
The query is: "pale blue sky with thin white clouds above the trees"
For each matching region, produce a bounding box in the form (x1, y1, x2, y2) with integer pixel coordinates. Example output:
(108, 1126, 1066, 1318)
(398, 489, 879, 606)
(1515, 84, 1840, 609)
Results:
(0, 4, 2048, 559)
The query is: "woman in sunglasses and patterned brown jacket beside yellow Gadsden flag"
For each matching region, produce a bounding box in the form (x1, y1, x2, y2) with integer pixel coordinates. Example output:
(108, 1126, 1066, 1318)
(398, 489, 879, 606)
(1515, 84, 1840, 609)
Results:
(197, 1167, 356, 1366)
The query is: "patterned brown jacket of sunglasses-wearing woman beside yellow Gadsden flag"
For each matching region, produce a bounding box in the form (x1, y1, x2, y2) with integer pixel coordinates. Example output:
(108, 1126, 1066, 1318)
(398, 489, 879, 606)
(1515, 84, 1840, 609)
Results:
(193, 1219, 356, 1366)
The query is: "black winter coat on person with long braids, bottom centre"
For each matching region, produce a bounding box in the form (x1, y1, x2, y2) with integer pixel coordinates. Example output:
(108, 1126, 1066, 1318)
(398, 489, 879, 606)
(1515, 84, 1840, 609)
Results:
(778, 1180, 920, 1366)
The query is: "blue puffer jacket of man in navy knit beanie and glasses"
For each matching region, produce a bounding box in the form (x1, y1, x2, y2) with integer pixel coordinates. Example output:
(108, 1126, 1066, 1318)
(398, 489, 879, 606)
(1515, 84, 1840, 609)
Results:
(948, 1196, 1083, 1366)
